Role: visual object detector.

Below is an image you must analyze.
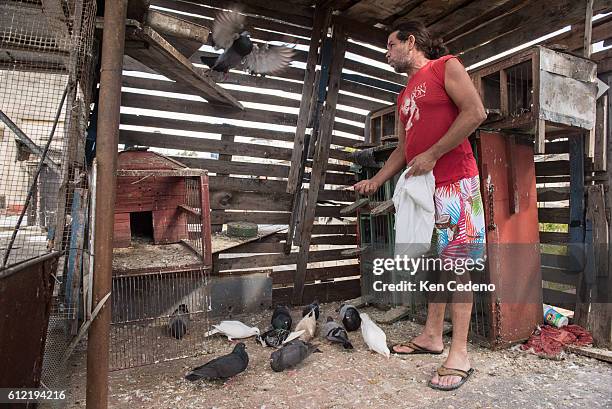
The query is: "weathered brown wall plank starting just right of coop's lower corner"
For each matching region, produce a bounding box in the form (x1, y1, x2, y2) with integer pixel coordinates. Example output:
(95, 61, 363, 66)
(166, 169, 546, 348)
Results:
(215, 245, 355, 271)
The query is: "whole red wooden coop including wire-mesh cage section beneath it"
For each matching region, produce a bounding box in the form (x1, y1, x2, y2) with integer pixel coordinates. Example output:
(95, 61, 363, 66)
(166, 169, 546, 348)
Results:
(110, 166, 212, 370)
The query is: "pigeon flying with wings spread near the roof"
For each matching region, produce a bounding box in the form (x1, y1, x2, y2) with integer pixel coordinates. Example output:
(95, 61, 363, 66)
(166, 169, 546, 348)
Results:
(200, 11, 294, 74)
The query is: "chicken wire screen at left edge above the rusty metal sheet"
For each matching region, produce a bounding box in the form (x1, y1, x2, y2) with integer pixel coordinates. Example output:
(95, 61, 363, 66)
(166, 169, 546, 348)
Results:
(0, 0, 97, 398)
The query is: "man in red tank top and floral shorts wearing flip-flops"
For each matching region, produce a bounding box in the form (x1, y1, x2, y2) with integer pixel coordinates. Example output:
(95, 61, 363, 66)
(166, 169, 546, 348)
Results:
(354, 22, 486, 390)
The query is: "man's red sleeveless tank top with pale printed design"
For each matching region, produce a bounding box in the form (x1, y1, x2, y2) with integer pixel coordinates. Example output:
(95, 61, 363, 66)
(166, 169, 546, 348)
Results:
(397, 55, 478, 187)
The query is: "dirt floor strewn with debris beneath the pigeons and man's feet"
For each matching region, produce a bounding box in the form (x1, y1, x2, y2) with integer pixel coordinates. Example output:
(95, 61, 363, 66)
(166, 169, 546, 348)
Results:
(68, 303, 612, 409)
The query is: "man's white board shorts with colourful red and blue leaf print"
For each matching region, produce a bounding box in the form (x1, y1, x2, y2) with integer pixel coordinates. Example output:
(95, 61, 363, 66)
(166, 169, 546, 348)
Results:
(432, 175, 486, 259)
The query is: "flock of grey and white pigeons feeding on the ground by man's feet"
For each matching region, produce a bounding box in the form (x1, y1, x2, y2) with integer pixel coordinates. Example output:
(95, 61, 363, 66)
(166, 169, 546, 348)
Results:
(182, 301, 390, 382)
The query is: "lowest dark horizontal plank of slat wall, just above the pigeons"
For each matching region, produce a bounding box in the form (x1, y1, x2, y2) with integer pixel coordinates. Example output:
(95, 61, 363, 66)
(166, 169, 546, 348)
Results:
(272, 280, 361, 304)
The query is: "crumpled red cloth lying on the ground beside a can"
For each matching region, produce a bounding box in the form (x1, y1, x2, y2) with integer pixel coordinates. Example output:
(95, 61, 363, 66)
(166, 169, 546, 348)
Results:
(521, 325, 593, 356)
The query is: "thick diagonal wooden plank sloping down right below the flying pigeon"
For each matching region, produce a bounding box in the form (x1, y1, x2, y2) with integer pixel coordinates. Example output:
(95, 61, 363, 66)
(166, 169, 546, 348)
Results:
(125, 27, 244, 109)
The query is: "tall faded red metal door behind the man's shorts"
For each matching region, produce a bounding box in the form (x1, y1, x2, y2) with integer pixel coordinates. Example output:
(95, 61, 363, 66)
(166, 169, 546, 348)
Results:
(477, 131, 542, 347)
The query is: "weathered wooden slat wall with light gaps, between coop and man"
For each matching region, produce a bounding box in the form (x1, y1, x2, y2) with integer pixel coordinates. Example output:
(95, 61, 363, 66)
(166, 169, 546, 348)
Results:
(120, 0, 405, 301)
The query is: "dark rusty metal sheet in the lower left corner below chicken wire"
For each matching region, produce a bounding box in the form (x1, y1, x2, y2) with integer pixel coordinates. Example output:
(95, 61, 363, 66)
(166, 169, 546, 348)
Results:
(0, 252, 59, 388)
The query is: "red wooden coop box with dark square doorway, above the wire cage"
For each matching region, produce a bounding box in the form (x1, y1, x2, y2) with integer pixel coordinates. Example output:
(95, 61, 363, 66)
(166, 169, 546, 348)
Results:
(113, 149, 211, 264)
